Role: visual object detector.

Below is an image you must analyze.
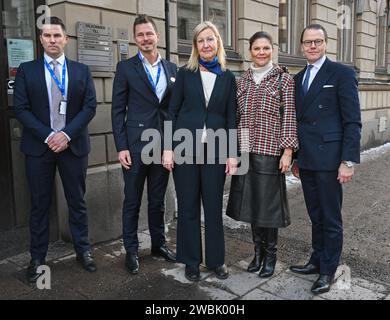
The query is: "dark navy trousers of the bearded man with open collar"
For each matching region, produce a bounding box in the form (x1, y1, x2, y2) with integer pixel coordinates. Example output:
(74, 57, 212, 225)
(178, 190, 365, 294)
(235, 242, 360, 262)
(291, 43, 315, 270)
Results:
(122, 153, 169, 253)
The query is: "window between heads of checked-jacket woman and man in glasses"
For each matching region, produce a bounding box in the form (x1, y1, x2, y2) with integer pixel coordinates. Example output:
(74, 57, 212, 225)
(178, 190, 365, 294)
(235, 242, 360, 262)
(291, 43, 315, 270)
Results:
(279, 0, 309, 56)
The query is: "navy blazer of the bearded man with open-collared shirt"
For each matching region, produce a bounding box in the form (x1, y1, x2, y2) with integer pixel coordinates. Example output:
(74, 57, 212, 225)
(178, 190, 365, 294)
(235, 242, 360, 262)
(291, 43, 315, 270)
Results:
(111, 55, 177, 153)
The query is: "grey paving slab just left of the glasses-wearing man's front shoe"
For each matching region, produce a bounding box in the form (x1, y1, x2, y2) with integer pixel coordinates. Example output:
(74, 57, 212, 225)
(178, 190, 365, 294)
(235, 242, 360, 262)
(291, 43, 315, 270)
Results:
(259, 272, 313, 300)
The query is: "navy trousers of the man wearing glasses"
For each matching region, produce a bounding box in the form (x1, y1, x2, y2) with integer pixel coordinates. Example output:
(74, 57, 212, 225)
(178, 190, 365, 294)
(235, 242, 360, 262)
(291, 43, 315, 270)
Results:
(299, 169, 343, 275)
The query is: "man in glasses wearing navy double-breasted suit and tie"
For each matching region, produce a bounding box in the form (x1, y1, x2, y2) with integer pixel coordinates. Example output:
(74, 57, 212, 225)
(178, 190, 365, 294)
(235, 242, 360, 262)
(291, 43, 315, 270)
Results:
(290, 24, 362, 294)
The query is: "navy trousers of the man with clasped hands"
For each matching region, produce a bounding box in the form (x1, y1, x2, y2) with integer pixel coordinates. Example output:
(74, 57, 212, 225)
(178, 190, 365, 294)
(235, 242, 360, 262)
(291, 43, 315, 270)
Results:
(26, 149, 91, 259)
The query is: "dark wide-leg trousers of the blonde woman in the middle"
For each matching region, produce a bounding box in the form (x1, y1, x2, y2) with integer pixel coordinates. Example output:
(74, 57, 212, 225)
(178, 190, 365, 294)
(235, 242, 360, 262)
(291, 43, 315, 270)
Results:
(173, 160, 226, 269)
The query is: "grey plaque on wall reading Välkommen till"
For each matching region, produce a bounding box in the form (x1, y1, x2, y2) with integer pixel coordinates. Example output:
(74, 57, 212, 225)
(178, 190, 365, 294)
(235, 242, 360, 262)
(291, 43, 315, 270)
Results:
(77, 22, 114, 77)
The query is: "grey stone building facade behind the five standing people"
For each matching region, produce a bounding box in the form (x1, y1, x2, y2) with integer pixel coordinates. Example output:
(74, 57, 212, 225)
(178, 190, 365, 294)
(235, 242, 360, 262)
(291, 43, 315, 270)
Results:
(2, 0, 390, 242)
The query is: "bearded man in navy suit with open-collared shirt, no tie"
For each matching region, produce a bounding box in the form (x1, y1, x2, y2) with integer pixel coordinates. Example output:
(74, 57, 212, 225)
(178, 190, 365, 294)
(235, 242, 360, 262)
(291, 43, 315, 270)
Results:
(112, 15, 177, 274)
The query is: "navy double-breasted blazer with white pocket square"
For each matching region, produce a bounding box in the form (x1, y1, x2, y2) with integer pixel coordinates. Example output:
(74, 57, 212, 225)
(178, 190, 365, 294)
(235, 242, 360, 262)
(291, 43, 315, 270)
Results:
(294, 59, 362, 171)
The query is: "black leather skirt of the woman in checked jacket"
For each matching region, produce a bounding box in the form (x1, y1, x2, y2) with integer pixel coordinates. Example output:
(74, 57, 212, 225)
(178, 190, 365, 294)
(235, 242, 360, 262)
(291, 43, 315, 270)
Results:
(226, 153, 290, 228)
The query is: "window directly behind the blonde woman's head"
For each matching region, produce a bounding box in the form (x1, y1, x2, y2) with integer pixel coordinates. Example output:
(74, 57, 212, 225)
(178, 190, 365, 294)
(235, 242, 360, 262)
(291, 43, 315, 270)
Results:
(177, 0, 233, 47)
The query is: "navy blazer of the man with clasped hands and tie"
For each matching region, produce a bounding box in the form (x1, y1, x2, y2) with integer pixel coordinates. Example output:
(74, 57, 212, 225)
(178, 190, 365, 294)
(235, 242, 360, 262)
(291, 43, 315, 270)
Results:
(14, 58, 96, 157)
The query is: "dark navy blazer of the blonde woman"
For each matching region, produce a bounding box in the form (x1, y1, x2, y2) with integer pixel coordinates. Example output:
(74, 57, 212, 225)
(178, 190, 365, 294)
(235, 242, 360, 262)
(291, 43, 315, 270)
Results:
(167, 66, 237, 157)
